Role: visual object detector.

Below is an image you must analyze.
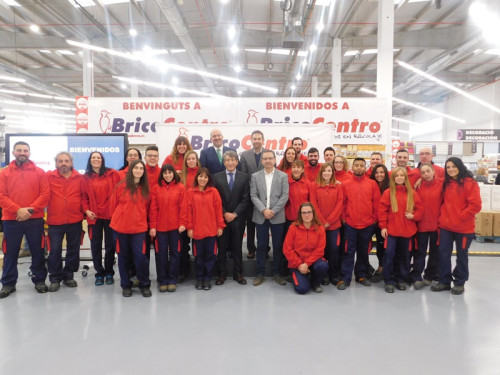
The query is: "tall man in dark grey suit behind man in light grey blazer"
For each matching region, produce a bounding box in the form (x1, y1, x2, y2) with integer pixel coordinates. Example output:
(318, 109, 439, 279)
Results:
(240, 130, 264, 259)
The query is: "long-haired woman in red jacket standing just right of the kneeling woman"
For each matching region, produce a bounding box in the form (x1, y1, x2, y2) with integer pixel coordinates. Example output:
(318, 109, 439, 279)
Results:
(311, 163, 344, 285)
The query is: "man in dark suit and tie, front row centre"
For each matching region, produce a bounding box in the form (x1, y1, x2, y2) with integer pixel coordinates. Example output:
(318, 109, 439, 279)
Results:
(214, 150, 250, 285)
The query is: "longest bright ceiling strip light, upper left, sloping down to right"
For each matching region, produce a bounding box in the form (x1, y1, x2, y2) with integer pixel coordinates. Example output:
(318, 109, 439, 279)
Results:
(66, 39, 278, 95)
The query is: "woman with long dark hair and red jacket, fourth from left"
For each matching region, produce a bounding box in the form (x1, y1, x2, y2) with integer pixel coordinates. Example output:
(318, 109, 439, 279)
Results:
(109, 160, 151, 297)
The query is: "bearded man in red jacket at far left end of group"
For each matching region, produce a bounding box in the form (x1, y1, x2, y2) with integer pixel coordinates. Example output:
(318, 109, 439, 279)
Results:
(0, 141, 50, 298)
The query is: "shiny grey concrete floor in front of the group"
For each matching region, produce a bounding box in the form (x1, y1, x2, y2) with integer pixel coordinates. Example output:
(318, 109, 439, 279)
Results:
(0, 251, 500, 375)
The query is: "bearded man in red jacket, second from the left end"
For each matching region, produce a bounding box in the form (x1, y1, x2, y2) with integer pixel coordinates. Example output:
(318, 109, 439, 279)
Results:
(47, 151, 91, 292)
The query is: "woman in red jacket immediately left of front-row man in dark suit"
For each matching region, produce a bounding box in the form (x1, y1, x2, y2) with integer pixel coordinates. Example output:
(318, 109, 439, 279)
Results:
(185, 168, 226, 290)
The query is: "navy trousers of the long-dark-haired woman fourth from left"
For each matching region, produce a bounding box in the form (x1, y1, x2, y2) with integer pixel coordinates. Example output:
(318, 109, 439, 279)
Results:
(115, 231, 151, 288)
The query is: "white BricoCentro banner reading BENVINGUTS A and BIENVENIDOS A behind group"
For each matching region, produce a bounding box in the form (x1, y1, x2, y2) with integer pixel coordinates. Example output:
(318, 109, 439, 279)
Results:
(86, 98, 391, 154)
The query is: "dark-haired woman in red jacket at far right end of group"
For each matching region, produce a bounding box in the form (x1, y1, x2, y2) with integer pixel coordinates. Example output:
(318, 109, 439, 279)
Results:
(431, 157, 481, 294)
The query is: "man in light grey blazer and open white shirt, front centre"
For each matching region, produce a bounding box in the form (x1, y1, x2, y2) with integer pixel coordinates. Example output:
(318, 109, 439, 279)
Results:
(250, 150, 288, 286)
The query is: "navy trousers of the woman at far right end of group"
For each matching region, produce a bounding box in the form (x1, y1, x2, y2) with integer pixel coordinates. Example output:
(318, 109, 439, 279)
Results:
(439, 228, 475, 285)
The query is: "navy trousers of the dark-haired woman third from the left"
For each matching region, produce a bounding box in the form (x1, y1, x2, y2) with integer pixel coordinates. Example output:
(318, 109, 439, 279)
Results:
(89, 219, 115, 277)
